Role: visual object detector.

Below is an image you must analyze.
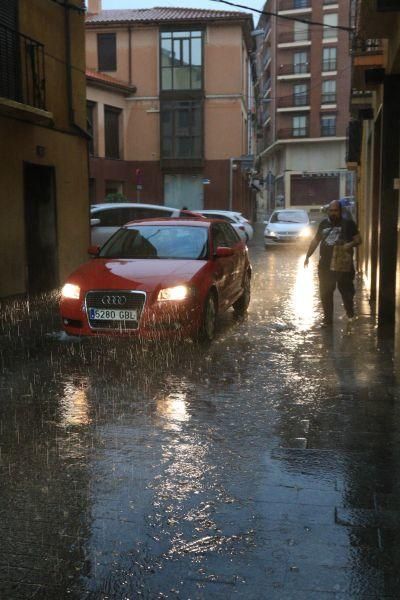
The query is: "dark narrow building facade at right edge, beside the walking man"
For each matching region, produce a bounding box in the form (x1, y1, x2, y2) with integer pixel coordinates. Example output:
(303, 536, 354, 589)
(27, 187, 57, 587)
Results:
(347, 0, 400, 328)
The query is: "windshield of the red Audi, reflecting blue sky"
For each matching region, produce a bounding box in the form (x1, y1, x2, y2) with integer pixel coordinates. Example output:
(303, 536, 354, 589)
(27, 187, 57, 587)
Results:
(99, 225, 208, 259)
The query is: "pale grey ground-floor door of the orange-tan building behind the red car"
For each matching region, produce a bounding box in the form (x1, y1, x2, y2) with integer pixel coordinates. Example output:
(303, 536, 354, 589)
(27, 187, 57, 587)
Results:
(164, 174, 204, 210)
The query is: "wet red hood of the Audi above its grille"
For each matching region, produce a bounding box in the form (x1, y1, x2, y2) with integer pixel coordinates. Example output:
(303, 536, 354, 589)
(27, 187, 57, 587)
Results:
(68, 258, 207, 292)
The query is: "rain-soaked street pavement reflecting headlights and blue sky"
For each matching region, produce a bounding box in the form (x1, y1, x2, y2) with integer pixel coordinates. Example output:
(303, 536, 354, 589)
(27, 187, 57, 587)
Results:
(0, 231, 400, 600)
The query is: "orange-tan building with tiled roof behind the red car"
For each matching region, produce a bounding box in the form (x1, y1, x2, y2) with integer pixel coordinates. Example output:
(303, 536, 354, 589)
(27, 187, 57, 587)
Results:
(86, 0, 255, 216)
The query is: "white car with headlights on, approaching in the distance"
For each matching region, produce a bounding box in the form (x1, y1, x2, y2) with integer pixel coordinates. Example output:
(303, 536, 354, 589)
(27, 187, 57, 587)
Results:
(264, 208, 313, 247)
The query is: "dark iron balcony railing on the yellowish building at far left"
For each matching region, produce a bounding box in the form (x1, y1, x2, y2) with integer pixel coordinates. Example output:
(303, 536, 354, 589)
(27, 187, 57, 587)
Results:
(0, 25, 46, 110)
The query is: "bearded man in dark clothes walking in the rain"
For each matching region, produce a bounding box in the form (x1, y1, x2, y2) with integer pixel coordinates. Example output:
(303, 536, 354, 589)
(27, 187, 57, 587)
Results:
(304, 200, 361, 327)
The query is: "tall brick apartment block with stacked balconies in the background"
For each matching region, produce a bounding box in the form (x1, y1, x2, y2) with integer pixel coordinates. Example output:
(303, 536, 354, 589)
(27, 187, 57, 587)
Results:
(255, 0, 353, 218)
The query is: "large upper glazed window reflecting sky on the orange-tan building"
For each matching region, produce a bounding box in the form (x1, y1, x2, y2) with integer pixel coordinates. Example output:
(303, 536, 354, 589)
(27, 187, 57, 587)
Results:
(160, 31, 203, 91)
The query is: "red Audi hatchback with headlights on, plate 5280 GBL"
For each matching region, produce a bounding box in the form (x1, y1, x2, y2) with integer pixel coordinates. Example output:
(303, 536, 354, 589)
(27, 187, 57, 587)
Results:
(60, 218, 251, 340)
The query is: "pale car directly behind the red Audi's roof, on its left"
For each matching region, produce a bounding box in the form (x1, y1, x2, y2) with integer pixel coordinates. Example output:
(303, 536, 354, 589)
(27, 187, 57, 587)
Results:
(90, 202, 193, 246)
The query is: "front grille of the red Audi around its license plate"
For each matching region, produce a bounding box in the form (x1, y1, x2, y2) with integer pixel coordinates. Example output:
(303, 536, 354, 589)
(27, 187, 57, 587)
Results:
(86, 290, 146, 331)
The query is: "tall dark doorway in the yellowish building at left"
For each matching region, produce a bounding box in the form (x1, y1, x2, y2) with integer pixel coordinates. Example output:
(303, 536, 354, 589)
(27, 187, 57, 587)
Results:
(24, 164, 59, 294)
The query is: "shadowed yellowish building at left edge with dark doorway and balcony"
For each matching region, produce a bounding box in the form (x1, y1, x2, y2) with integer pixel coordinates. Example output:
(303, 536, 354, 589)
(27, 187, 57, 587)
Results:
(0, 0, 89, 297)
